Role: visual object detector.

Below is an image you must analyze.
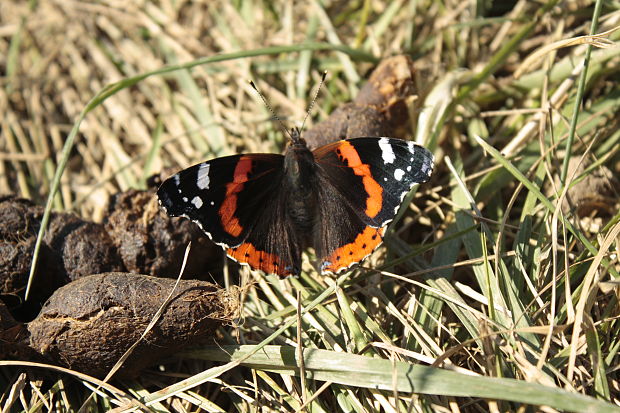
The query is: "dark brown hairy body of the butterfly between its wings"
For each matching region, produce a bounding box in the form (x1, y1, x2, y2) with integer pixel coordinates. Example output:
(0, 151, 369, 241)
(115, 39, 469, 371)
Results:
(284, 139, 316, 234)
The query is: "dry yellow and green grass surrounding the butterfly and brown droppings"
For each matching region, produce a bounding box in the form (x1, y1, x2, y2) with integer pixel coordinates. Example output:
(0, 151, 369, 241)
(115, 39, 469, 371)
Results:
(0, 0, 620, 412)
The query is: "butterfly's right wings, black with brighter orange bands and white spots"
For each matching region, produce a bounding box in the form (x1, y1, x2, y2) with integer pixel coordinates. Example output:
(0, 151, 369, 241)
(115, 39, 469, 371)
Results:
(313, 137, 434, 273)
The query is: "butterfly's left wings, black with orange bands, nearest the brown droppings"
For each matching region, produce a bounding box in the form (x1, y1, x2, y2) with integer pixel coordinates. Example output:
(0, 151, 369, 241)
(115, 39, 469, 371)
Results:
(157, 154, 301, 275)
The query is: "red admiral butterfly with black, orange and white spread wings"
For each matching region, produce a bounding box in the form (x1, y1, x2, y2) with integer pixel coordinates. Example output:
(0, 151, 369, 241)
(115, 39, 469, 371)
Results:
(157, 129, 433, 276)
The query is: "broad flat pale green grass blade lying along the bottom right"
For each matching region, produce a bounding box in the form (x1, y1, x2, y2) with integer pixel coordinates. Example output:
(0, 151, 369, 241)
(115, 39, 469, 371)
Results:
(194, 345, 620, 412)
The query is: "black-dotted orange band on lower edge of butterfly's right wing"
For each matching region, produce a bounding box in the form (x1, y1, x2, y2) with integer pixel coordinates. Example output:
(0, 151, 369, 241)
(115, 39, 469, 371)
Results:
(321, 226, 386, 273)
